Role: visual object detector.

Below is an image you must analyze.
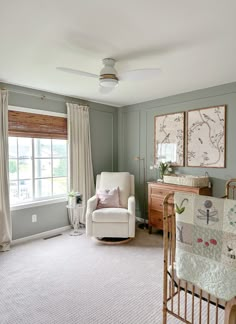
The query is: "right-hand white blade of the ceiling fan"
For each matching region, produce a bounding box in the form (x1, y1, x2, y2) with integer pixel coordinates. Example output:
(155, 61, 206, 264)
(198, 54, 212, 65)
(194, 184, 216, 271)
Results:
(119, 68, 161, 81)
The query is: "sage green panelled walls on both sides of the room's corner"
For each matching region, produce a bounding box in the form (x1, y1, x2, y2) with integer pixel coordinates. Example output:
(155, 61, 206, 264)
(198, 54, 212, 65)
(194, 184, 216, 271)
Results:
(0, 83, 236, 239)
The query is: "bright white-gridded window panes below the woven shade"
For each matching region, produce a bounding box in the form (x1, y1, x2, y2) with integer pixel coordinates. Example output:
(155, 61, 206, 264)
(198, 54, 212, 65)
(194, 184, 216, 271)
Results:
(9, 137, 67, 205)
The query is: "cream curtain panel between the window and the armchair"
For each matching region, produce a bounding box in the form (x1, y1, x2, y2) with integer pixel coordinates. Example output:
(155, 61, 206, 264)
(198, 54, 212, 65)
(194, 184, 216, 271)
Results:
(67, 103, 94, 224)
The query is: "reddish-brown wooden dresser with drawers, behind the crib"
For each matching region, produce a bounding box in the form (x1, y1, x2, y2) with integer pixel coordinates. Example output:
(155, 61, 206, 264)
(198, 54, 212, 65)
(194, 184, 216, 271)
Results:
(148, 182, 212, 234)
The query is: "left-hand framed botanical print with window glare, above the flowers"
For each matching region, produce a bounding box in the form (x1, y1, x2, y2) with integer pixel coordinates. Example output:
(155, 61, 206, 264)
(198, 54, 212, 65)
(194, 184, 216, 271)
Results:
(154, 112, 185, 166)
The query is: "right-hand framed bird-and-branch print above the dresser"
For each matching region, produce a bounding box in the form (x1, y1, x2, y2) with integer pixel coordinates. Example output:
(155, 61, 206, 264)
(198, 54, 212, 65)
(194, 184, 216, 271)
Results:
(187, 106, 226, 168)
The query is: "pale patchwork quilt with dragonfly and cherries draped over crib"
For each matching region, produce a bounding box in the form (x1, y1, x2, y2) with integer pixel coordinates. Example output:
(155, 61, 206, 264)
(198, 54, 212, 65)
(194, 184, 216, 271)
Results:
(174, 192, 236, 301)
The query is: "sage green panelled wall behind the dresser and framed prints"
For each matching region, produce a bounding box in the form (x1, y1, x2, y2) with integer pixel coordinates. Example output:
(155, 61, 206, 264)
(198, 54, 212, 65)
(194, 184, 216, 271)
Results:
(118, 83, 236, 219)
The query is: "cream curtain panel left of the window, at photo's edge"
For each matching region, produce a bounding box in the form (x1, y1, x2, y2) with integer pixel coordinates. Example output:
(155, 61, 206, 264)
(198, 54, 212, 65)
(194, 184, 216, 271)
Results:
(0, 90, 12, 252)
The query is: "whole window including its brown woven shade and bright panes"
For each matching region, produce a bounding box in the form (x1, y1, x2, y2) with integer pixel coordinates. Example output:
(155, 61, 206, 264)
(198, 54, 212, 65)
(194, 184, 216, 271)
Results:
(8, 106, 67, 205)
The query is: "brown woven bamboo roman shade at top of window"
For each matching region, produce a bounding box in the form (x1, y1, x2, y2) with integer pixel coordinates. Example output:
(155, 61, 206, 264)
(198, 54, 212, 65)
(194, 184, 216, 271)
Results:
(8, 110, 67, 139)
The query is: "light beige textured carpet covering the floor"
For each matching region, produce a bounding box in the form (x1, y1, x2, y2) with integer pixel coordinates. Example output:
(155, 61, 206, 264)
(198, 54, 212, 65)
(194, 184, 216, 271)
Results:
(0, 229, 223, 324)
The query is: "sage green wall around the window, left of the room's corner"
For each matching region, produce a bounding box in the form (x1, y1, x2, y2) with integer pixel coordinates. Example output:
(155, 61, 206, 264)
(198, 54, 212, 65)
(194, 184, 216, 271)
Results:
(0, 83, 118, 239)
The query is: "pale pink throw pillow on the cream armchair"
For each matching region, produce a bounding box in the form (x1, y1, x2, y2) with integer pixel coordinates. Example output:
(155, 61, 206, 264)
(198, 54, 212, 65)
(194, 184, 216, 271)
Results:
(96, 187, 120, 209)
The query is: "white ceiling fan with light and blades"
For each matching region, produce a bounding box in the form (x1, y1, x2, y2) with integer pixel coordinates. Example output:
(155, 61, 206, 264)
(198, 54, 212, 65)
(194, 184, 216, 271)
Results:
(57, 58, 161, 94)
